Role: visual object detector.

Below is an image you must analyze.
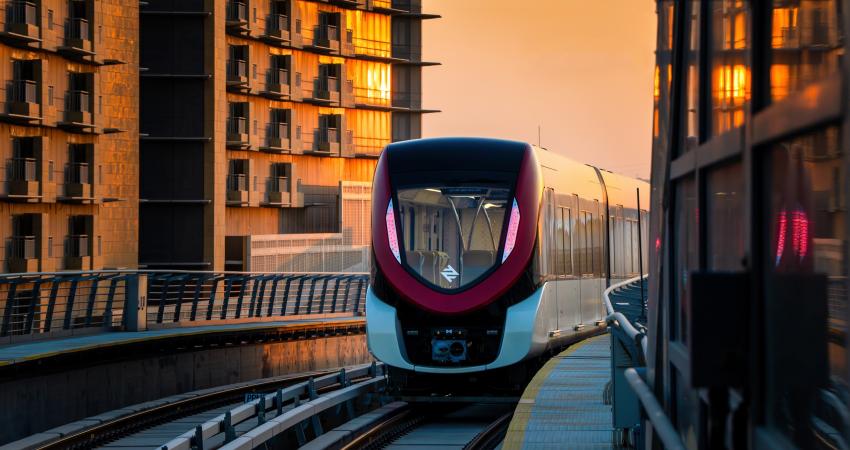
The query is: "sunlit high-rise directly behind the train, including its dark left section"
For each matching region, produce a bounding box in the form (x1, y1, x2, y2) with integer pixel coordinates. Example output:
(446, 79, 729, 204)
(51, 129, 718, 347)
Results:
(139, 0, 435, 272)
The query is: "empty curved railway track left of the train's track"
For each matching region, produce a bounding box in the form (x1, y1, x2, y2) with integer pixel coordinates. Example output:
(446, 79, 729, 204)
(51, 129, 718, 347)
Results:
(39, 371, 336, 450)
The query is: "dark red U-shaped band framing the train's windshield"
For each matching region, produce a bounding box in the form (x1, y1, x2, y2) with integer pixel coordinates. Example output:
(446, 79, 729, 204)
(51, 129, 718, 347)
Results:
(372, 147, 543, 314)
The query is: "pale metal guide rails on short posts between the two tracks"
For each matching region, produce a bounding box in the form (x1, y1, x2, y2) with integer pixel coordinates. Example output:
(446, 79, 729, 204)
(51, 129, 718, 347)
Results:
(159, 363, 384, 450)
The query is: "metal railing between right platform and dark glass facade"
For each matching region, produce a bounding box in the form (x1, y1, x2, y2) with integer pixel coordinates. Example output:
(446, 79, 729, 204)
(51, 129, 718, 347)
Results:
(602, 275, 686, 450)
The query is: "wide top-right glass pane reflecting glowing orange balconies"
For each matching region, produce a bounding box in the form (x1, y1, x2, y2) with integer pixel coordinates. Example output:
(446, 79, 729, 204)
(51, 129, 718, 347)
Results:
(770, 0, 842, 100)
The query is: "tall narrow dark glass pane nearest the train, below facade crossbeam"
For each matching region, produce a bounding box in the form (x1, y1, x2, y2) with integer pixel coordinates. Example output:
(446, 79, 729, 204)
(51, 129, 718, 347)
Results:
(671, 179, 699, 341)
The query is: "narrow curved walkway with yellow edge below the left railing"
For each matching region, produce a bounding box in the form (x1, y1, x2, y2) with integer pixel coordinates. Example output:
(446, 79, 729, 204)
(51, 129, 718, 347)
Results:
(0, 314, 366, 369)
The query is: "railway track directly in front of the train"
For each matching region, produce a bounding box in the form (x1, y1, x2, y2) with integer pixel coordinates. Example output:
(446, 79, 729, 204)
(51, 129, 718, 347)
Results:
(342, 402, 515, 450)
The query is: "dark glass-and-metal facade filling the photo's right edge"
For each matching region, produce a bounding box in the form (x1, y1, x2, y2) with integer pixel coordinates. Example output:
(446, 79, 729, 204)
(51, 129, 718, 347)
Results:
(646, 0, 850, 449)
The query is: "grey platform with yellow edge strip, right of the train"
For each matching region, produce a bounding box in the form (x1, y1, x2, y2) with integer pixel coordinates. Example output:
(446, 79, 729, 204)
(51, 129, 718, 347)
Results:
(502, 334, 620, 450)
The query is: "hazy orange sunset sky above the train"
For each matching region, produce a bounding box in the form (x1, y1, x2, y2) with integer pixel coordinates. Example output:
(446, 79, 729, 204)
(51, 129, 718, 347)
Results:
(422, 0, 656, 178)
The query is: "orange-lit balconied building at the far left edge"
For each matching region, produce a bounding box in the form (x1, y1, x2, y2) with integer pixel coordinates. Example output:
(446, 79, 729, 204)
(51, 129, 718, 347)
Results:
(0, 0, 139, 272)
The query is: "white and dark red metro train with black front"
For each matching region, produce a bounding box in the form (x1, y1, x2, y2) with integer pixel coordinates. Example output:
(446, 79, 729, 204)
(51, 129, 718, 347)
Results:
(366, 138, 649, 394)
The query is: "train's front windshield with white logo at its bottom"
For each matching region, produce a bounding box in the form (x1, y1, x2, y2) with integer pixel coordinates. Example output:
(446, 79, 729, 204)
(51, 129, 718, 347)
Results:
(398, 183, 511, 289)
